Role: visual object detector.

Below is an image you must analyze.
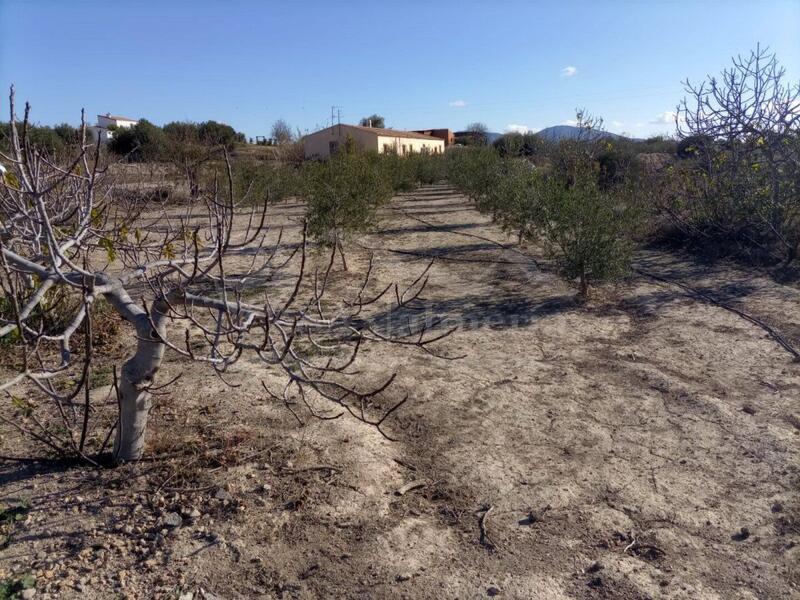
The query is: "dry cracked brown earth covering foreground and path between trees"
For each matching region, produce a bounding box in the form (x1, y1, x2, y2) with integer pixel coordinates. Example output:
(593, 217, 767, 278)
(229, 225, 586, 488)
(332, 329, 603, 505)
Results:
(0, 187, 800, 600)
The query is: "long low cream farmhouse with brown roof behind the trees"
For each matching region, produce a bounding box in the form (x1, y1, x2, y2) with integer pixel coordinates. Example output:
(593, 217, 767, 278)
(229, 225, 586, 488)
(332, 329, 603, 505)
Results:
(303, 125, 445, 158)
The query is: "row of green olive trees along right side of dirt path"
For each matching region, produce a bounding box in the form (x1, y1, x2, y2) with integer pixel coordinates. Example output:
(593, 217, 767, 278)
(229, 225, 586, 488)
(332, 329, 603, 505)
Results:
(447, 113, 641, 299)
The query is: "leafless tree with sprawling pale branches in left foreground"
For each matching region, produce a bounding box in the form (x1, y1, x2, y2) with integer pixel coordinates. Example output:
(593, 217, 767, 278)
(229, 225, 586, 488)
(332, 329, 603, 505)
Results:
(0, 88, 456, 461)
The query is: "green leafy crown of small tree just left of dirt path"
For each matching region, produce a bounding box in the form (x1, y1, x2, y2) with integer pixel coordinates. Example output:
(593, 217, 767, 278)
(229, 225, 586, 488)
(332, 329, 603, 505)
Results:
(301, 153, 393, 244)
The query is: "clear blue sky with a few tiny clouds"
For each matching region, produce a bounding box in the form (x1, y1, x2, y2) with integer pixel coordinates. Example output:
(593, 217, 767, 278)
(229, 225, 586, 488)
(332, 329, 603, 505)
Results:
(0, 0, 800, 136)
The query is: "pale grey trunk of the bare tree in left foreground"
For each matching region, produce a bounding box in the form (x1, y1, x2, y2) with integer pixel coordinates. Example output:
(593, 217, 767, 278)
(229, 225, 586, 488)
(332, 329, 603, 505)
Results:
(114, 303, 166, 462)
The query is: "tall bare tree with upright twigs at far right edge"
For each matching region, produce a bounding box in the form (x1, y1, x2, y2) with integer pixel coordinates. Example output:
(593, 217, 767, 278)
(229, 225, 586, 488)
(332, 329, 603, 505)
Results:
(676, 45, 800, 262)
